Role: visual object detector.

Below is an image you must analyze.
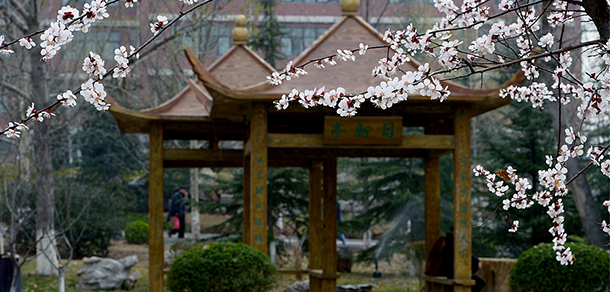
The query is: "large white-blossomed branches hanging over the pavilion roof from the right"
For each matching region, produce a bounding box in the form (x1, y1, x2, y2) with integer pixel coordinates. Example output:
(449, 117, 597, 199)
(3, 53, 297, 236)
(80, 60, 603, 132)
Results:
(267, 0, 610, 265)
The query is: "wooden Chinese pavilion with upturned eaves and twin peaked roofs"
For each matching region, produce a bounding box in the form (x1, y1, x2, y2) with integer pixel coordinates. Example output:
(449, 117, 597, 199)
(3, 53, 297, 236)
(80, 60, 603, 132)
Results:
(110, 0, 522, 292)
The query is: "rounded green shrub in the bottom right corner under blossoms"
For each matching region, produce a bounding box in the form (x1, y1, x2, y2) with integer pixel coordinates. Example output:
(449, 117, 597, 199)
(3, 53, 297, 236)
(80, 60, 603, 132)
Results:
(510, 243, 610, 292)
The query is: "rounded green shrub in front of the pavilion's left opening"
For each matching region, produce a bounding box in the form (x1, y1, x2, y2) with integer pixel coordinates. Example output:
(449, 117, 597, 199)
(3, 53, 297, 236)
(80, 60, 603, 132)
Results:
(167, 242, 275, 292)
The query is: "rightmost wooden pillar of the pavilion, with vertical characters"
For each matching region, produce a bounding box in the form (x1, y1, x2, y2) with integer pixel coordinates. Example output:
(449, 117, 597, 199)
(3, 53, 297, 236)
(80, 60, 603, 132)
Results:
(453, 106, 472, 292)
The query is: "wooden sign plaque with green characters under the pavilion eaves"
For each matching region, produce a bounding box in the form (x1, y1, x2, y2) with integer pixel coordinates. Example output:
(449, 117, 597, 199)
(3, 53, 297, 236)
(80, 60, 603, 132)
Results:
(324, 117, 402, 145)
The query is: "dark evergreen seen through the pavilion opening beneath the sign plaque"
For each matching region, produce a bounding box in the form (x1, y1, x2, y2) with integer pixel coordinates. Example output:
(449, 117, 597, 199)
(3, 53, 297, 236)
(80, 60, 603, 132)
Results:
(339, 156, 452, 261)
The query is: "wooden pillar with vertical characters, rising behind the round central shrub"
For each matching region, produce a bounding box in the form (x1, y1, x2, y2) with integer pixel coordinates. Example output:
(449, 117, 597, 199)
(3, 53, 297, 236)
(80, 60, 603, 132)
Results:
(246, 103, 267, 254)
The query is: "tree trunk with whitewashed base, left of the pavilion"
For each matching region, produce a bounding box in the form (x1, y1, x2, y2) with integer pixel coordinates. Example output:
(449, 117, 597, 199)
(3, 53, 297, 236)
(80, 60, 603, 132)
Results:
(28, 10, 58, 275)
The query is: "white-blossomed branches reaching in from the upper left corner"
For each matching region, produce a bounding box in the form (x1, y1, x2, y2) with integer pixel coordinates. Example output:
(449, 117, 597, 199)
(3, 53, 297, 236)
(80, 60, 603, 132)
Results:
(0, 0, 214, 138)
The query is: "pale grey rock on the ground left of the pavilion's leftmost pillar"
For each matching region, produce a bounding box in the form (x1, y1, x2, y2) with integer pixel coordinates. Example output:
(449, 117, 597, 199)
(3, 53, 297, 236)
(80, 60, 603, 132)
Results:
(76, 255, 140, 290)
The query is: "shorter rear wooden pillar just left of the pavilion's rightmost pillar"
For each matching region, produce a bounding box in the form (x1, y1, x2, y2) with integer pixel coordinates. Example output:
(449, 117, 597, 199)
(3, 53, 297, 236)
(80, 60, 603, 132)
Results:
(424, 155, 441, 255)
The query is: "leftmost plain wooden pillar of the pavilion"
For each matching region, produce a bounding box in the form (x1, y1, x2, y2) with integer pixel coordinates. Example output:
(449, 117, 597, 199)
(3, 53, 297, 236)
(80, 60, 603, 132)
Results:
(148, 122, 163, 292)
